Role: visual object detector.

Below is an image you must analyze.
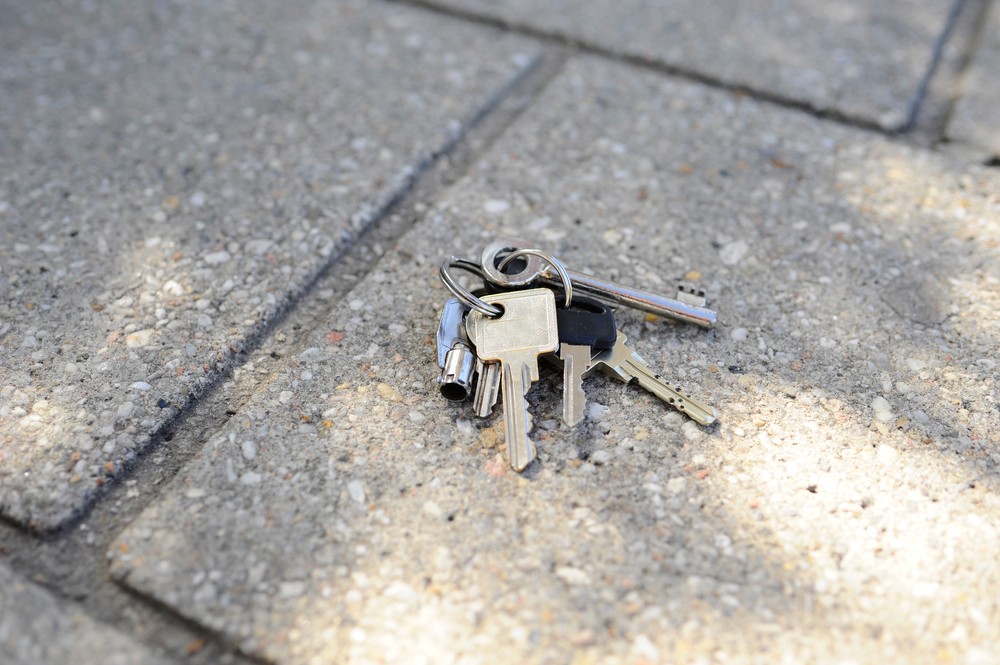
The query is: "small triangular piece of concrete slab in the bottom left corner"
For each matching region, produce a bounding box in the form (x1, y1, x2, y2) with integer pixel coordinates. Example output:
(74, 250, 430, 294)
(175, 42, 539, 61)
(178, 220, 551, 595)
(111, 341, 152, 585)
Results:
(0, 564, 173, 665)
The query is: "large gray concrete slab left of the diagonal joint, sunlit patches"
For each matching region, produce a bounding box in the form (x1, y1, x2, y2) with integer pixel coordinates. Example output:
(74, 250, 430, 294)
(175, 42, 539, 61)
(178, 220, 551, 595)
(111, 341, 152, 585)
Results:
(0, 0, 537, 529)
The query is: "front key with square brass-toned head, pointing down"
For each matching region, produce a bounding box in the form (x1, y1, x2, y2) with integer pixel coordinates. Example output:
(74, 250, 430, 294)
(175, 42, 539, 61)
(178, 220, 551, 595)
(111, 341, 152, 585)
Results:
(465, 289, 559, 471)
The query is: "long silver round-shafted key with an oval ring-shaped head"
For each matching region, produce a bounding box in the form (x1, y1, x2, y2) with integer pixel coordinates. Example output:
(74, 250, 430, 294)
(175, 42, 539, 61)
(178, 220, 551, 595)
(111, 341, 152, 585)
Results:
(481, 239, 716, 328)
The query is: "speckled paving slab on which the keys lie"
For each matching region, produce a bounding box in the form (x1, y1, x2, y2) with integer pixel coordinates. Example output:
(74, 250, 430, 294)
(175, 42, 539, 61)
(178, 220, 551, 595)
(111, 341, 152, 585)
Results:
(108, 58, 1000, 665)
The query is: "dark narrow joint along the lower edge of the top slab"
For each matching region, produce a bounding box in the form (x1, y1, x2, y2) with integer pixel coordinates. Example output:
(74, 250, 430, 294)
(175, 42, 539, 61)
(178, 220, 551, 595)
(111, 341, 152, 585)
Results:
(386, 0, 908, 136)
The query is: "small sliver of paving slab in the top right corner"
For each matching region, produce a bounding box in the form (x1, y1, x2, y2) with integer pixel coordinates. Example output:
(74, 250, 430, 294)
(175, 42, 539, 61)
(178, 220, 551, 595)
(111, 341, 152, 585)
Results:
(947, 3, 1000, 157)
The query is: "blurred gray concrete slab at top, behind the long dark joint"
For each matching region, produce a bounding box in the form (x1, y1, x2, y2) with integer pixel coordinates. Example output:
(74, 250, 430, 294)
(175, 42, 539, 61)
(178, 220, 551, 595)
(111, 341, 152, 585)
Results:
(422, 0, 951, 129)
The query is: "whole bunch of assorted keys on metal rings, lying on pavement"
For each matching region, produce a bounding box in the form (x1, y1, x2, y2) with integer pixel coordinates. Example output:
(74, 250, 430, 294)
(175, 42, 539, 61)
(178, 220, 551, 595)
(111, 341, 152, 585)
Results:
(437, 239, 718, 472)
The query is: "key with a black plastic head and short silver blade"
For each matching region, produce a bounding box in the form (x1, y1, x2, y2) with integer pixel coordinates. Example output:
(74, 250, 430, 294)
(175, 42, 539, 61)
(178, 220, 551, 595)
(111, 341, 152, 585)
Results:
(556, 297, 618, 427)
